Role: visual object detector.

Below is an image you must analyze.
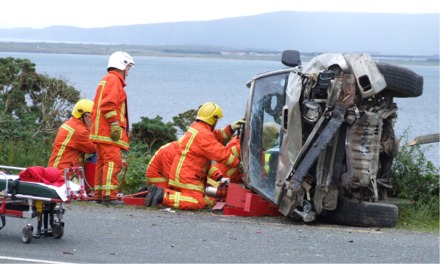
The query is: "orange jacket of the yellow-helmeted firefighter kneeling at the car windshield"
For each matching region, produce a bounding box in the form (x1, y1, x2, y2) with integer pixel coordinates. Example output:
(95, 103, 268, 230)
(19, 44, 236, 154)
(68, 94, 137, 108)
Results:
(169, 121, 240, 193)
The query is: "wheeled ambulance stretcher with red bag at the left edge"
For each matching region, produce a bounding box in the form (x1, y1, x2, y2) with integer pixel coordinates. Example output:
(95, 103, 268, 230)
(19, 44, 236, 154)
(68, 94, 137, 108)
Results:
(0, 165, 87, 243)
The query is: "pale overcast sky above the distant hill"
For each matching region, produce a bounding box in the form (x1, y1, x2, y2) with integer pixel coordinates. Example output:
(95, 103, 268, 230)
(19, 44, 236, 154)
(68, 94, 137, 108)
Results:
(0, 0, 440, 28)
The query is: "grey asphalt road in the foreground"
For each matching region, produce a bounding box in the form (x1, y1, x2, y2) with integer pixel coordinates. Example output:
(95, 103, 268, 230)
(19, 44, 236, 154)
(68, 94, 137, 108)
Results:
(0, 202, 439, 263)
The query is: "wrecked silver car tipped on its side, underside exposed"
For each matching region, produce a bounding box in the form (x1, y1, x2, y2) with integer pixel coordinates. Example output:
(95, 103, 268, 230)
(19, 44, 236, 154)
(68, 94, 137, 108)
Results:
(241, 51, 423, 226)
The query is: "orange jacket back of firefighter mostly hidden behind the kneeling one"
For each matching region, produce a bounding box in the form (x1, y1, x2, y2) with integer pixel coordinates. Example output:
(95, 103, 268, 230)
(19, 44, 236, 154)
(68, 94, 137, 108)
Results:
(145, 141, 179, 188)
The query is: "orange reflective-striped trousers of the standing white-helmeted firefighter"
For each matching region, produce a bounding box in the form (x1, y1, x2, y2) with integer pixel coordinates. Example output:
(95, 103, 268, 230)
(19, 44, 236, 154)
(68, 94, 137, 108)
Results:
(94, 143, 122, 200)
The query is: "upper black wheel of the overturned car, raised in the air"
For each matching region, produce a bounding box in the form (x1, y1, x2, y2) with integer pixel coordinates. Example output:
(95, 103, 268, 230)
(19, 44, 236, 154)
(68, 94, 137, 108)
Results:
(376, 62, 423, 97)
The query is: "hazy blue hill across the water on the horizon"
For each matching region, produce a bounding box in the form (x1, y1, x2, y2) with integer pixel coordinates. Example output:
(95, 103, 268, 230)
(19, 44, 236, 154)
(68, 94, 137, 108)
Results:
(0, 11, 440, 56)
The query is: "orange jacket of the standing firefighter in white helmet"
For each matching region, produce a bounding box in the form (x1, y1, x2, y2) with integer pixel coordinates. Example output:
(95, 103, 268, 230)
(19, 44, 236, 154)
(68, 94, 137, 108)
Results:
(90, 71, 130, 150)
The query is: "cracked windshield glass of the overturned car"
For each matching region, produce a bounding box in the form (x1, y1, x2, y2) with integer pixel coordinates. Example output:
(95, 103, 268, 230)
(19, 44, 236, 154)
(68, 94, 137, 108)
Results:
(249, 72, 289, 201)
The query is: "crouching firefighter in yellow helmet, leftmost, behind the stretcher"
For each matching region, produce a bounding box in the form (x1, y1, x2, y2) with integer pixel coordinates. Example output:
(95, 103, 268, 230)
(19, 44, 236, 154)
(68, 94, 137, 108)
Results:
(47, 99, 96, 174)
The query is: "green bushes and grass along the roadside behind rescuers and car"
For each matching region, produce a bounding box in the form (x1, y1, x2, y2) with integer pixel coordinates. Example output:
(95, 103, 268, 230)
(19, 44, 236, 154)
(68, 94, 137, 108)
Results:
(0, 58, 440, 232)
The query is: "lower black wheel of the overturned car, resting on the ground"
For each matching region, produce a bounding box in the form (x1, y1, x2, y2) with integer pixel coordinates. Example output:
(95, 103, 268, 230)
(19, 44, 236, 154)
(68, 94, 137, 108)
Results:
(327, 199, 399, 227)
